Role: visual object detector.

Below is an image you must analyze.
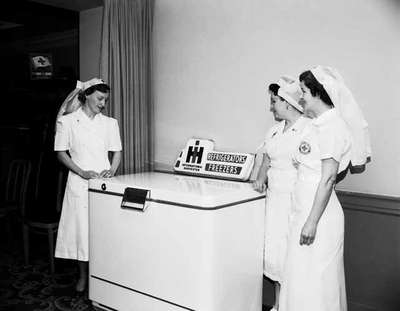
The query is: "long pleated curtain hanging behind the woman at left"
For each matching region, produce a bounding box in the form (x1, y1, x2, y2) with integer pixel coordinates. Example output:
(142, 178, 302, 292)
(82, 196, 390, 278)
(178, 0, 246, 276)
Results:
(100, 0, 154, 174)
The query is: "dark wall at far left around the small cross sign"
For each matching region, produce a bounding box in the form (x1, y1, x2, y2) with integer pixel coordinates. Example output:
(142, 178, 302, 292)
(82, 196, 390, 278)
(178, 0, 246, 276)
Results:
(0, 0, 79, 207)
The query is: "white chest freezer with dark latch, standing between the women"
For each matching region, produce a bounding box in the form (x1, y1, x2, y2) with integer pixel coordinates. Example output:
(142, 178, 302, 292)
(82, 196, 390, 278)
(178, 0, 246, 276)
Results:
(89, 173, 265, 311)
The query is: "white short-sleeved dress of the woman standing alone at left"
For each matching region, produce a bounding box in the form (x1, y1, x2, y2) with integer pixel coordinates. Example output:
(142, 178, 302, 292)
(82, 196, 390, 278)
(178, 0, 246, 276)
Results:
(54, 108, 122, 261)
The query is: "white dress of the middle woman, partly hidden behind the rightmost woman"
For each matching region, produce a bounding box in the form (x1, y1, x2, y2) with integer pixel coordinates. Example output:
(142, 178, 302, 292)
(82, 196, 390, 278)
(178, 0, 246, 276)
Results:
(264, 117, 310, 282)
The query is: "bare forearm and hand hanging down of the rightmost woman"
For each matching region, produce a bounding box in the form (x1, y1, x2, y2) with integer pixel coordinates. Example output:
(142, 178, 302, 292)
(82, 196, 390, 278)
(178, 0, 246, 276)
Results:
(300, 158, 339, 245)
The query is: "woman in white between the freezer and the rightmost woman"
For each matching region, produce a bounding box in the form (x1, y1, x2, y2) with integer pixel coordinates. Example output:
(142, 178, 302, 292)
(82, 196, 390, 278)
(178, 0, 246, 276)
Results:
(253, 77, 310, 310)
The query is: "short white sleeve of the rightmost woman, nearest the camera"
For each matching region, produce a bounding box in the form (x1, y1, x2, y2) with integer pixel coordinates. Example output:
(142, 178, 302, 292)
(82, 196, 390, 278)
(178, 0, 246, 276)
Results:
(318, 127, 347, 163)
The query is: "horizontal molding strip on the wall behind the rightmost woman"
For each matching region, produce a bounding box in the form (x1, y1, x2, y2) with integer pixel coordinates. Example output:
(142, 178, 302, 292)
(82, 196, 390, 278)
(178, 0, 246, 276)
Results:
(336, 190, 400, 217)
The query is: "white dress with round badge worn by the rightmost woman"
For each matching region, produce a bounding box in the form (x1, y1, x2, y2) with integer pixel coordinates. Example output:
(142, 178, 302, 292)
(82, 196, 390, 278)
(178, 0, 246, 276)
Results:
(279, 109, 351, 311)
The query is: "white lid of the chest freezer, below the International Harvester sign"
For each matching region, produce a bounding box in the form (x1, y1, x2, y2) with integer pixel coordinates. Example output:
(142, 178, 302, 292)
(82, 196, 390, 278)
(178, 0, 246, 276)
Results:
(89, 172, 265, 209)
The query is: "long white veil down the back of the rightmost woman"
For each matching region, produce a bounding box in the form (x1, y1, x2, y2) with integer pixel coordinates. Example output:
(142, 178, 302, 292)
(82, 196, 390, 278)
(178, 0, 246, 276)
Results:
(311, 66, 371, 178)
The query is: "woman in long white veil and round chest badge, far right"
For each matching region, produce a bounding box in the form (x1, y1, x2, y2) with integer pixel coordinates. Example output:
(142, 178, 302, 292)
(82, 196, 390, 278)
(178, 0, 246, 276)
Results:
(279, 66, 370, 311)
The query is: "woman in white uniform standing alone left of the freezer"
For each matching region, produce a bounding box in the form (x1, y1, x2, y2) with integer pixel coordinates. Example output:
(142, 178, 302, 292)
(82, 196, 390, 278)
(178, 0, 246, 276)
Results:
(54, 78, 122, 292)
